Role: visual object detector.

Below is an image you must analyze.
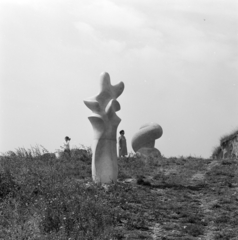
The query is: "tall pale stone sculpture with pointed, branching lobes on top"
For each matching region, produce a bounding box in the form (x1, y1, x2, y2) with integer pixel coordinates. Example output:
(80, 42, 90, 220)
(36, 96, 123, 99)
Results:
(84, 73, 124, 183)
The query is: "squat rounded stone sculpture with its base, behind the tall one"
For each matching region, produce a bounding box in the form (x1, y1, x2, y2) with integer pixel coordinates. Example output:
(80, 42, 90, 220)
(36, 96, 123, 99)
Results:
(131, 123, 163, 157)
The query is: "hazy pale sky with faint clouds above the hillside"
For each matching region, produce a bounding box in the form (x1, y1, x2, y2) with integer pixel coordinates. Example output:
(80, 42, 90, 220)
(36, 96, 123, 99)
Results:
(0, 0, 238, 157)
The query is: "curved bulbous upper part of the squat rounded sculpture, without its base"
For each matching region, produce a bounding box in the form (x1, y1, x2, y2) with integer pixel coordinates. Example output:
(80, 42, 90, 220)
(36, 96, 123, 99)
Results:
(131, 123, 163, 152)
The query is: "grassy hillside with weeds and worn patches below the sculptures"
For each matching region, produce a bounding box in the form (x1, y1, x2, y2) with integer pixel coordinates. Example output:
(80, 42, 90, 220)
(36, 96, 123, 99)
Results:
(0, 149, 238, 240)
